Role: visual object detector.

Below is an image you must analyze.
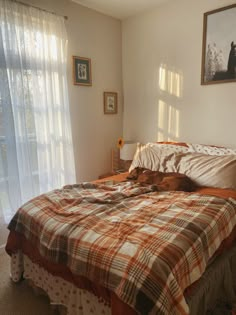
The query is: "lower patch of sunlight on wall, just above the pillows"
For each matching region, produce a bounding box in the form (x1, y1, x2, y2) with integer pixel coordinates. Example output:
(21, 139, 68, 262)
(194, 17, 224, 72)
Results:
(157, 100, 180, 141)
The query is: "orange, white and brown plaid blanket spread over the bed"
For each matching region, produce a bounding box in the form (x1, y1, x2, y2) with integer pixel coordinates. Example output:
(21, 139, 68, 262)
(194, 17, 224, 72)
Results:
(9, 183, 236, 315)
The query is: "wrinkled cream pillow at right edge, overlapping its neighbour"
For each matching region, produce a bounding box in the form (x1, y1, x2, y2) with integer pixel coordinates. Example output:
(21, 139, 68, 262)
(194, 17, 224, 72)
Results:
(177, 153, 236, 189)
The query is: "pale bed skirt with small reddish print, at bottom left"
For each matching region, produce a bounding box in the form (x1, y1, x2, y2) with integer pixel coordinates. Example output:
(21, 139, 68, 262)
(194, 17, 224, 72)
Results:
(11, 252, 111, 315)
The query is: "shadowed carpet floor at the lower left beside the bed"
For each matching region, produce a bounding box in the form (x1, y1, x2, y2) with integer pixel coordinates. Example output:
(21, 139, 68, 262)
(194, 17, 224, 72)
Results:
(0, 253, 55, 315)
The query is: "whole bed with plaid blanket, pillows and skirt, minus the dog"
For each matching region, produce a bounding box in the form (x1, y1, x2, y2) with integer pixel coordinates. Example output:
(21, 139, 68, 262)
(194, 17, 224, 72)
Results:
(6, 142, 236, 315)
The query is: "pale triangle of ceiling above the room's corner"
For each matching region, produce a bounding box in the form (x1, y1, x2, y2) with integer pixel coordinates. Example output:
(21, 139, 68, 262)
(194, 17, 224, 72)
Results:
(71, 0, 170, 20)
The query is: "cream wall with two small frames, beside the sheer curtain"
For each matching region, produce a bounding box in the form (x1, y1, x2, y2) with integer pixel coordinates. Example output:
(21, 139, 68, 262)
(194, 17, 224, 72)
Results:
(24, 0, 123, 182)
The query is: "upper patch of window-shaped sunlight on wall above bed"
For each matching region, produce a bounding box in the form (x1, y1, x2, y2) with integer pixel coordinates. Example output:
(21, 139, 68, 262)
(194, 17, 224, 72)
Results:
(159, 64, 183, 98)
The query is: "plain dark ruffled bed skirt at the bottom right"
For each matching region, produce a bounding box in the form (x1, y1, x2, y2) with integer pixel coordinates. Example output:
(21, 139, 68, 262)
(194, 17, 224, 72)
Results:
(186, 246, 236, 315)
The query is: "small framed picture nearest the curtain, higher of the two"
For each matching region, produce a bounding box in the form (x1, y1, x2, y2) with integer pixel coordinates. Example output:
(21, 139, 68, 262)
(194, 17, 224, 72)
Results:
(73, 56, 92, 85)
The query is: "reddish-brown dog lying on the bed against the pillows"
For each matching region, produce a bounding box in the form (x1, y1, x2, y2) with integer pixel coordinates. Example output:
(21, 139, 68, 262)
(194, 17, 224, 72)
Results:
(126, 167, 196, 192)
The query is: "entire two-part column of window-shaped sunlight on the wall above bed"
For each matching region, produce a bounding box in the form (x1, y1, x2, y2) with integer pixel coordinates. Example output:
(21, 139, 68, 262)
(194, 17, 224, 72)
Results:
(157, 64, 183, 141)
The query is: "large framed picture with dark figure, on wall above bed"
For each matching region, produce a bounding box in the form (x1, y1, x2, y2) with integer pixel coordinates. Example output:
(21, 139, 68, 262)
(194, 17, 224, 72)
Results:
(201, 4, 236, 84)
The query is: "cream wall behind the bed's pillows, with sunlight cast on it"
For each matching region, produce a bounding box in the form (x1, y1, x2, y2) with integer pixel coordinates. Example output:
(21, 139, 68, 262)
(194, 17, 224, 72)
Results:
(122, 0, 236, 147)
